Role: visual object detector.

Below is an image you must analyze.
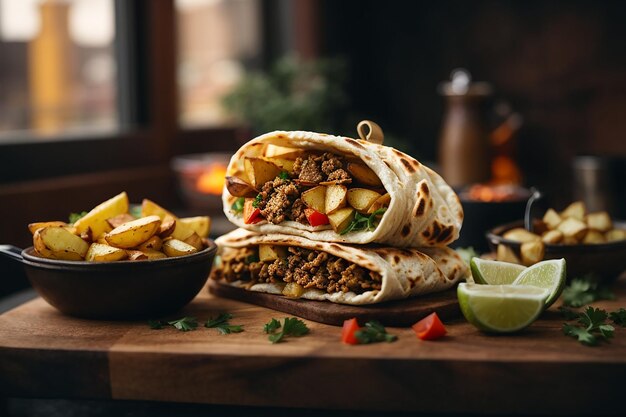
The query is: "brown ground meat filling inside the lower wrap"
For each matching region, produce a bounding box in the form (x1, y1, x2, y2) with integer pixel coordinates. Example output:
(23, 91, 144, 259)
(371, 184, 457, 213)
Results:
(218, 247, 382, 294)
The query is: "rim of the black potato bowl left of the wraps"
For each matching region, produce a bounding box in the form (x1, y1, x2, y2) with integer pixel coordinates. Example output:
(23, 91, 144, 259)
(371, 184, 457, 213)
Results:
(21, 238, 217, 272)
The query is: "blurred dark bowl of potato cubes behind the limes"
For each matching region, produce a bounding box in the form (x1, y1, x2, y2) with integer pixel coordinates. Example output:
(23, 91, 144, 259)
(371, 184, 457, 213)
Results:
(487, 201, 626, 282)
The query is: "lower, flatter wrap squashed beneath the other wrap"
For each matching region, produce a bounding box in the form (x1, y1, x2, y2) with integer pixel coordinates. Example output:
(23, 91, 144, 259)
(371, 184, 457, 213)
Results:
(211, 229, 468, 305)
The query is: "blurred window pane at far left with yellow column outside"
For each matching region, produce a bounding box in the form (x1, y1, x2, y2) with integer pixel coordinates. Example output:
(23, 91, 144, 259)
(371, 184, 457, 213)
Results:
(0, 0, 119, 142)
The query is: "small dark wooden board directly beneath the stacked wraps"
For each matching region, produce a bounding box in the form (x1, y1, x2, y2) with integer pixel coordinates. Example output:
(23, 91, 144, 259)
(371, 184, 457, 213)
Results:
(209, 279, 461, 327)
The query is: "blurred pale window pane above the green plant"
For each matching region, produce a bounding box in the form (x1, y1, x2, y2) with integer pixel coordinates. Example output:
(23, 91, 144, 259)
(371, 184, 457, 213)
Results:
(176, 0, 262, 127)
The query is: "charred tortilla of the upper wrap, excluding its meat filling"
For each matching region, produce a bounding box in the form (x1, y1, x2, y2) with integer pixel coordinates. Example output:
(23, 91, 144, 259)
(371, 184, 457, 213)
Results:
(222, 131, 463, 247)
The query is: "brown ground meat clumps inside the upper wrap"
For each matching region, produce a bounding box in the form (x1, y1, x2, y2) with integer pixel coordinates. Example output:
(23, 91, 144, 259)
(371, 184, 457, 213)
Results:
(257, 152, 352, 224)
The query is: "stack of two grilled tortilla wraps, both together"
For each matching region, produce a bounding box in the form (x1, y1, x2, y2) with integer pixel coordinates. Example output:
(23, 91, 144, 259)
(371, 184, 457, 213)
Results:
(212, 131, 468, 305)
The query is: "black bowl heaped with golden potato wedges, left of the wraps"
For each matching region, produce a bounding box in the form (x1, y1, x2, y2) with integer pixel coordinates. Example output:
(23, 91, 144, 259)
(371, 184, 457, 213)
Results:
(1, 193, 217, 320)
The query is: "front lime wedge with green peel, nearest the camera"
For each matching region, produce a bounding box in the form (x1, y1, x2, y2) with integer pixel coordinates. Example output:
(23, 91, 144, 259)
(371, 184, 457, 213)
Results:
(457, 283, 549, 333)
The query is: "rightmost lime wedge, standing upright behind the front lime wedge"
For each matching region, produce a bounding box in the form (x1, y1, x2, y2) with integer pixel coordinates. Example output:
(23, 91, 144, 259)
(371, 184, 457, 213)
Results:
(513, 259, 565, 308)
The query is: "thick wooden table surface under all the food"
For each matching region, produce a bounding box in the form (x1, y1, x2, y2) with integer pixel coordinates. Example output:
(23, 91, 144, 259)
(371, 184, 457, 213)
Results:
(0, 279, 626, 414)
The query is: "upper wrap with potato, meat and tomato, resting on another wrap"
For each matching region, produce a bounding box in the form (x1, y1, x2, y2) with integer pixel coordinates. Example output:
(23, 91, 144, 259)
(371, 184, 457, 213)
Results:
(222, 131, 463, 247)
